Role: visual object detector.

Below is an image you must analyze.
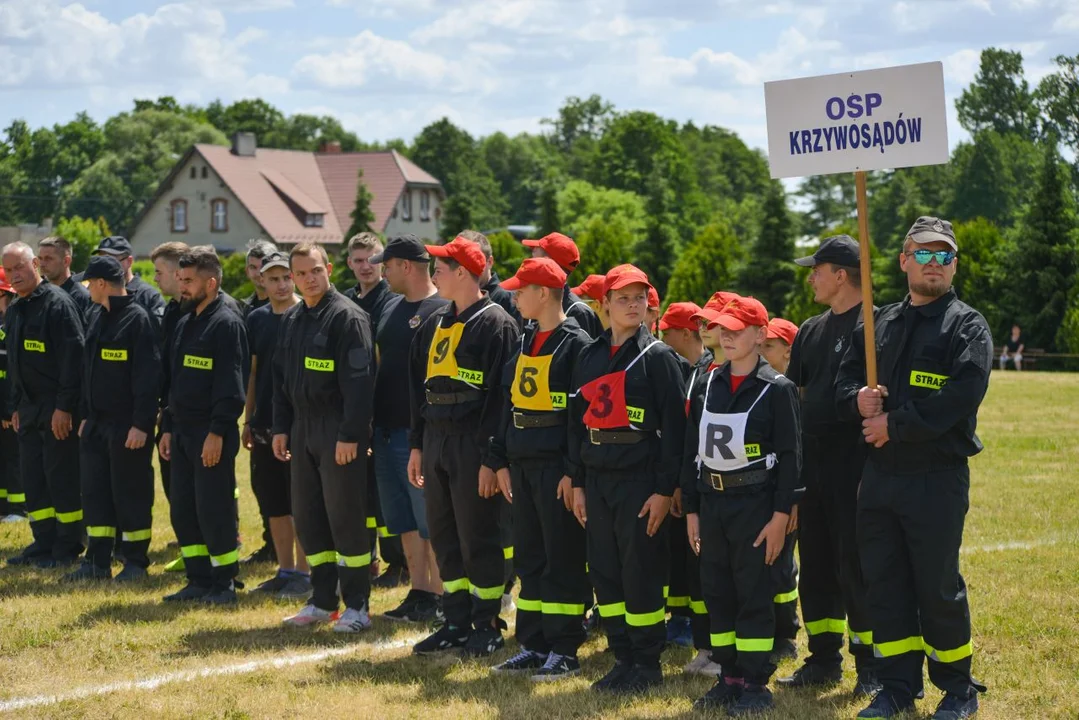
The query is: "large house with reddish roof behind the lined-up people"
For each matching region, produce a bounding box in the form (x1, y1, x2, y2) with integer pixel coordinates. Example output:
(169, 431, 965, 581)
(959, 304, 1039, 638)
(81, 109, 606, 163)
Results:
(128, 133, 446, 257)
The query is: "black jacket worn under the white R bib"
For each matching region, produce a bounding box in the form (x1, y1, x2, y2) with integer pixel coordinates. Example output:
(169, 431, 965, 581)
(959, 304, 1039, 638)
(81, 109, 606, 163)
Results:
(681, 357, 805, 514)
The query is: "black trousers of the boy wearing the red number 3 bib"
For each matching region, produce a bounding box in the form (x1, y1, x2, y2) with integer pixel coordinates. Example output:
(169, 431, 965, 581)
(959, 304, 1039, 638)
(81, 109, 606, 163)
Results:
(585, 468, 670, 668)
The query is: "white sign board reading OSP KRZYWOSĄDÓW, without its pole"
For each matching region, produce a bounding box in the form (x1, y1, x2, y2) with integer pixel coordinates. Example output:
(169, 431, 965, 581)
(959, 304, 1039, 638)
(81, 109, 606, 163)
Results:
(764, 63, 948, 178)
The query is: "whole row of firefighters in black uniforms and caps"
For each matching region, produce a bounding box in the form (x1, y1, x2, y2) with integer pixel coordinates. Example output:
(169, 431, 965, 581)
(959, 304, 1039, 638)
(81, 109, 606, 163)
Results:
(0, 217, 994, 720)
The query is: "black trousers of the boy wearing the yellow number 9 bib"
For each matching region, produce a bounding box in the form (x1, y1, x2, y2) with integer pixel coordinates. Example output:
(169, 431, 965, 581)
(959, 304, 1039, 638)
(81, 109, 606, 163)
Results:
(423, 426, 505, 627)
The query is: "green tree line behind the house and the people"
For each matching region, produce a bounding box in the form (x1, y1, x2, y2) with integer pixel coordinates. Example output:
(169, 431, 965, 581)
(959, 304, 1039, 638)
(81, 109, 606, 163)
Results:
(0, 47, 1079, 352)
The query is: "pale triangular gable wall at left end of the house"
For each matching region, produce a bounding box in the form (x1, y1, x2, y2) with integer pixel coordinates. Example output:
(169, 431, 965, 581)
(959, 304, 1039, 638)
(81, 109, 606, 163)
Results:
(128, 152, 265, 257)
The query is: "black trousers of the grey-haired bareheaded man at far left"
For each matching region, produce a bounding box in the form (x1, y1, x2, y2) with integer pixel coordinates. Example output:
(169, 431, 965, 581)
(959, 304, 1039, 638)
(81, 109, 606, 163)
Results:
(18, 418, 82, 559)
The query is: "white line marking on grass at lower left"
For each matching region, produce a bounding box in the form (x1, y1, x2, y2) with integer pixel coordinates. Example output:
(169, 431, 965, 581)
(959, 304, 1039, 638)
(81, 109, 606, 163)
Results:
(0, 637, 423, 712)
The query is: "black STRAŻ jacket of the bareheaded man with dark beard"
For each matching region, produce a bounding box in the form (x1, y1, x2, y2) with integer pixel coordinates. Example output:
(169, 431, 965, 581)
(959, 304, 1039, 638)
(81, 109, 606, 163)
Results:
(159, 296, 250, 436)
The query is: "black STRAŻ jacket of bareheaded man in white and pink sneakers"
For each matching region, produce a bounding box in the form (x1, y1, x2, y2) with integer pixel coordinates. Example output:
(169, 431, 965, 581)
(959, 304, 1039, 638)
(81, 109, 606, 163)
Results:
(273, 286, 374, 446)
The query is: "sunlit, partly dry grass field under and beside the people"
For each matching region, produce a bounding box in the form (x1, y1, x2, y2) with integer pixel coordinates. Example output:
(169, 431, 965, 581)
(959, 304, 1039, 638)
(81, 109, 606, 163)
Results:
(0, 372, 1079, 720)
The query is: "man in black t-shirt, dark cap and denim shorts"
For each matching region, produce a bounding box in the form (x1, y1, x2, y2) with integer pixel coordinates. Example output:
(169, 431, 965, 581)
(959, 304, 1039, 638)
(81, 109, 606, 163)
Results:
(370, 234, 447, 622)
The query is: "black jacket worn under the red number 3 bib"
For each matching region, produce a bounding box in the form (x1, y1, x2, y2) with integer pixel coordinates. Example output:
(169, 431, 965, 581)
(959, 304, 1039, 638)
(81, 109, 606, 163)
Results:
(566, 325, 685, 495)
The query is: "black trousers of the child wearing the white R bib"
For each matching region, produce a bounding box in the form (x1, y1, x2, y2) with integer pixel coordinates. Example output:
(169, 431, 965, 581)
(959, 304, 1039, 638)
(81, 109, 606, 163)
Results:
(699, 490, 776, 685)
